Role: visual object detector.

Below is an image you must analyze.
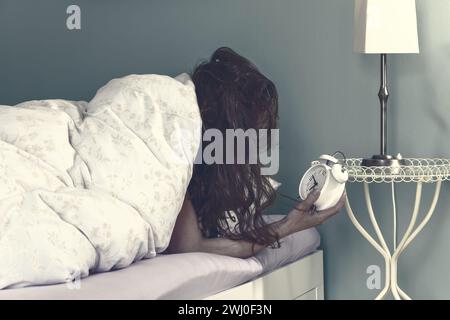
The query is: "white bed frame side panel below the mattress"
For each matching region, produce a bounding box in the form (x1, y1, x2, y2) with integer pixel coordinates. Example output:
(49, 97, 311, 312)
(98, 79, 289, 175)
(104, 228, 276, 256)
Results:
(206, 250, 324, 300)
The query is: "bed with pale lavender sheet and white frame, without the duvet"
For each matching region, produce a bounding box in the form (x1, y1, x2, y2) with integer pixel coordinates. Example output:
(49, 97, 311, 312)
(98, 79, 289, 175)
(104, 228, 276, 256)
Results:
(0, 220, 323, 300)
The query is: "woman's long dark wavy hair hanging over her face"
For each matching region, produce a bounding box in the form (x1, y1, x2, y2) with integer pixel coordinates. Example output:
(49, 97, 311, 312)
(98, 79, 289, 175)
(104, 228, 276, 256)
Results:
(188, 47, 279, 245)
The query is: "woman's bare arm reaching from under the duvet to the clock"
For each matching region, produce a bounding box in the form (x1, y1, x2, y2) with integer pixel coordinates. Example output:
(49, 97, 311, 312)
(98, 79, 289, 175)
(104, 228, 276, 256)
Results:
(166, 192, 344, 258)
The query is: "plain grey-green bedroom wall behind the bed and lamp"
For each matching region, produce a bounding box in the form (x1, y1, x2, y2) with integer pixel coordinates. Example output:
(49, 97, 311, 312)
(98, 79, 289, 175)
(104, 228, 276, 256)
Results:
(0, 0, 450, 299)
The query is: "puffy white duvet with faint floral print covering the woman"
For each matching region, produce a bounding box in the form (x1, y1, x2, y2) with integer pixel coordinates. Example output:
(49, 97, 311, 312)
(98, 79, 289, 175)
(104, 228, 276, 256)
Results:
(0, 74, 201, 289)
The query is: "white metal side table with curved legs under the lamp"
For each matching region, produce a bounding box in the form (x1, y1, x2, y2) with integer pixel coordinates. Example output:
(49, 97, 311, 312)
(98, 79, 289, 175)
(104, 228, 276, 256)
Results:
(344, 158, 450, 300)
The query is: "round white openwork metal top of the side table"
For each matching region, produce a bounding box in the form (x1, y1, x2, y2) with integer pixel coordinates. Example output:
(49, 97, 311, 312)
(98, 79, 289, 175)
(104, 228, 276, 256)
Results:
(343, 158, 450, 183)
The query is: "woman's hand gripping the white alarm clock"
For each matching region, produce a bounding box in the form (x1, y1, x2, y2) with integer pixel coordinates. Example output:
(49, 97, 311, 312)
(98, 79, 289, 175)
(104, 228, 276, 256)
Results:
(281, 191, 345, 237)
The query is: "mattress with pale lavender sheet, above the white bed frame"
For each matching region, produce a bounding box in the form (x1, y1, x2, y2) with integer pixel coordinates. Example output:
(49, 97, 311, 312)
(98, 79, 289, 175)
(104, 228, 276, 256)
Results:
(0, 217, 320, 300)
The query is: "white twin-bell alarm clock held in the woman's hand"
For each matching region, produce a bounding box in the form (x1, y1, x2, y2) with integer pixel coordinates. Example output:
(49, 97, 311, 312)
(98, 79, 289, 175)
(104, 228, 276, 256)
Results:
(298, 155, 348, 211)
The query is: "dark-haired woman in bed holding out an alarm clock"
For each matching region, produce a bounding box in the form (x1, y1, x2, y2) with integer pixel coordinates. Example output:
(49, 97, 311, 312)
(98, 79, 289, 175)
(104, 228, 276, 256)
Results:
(167, 48, 344, 258)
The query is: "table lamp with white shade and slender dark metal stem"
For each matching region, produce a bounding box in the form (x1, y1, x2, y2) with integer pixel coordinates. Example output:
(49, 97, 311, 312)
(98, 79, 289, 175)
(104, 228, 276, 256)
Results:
(353, 0, 419, 166)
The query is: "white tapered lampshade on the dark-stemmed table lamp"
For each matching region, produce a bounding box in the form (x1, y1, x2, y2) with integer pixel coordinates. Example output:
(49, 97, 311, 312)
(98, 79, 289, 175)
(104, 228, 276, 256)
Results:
(353, 0, 419, 54)
